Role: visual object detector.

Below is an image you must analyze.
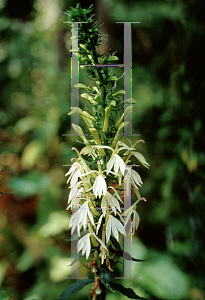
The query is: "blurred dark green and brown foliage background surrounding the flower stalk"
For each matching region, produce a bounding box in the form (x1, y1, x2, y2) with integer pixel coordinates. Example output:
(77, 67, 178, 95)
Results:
(0, 0, 205, 300)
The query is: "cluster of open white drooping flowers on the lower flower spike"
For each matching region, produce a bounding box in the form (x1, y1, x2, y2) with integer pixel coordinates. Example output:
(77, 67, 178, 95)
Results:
(66, 137, 148, 264)
